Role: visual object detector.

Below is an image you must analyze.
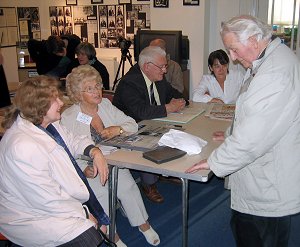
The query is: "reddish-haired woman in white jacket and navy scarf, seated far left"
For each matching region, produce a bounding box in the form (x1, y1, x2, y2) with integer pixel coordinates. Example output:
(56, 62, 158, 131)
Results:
(0, 76, 109, 247)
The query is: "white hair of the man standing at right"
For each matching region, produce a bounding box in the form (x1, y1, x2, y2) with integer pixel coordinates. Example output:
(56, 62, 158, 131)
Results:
(220, 15, 273, 44)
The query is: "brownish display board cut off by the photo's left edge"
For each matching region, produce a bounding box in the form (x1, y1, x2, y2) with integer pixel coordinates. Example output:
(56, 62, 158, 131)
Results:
(0, 7, 18, 47)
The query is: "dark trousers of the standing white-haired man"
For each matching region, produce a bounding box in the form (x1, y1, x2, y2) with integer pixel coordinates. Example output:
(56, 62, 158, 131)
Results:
(230, 210, 291, 247)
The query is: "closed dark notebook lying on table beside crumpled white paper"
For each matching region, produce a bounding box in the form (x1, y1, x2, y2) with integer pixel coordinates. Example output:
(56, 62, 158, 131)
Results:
(143, 146, 186, 164)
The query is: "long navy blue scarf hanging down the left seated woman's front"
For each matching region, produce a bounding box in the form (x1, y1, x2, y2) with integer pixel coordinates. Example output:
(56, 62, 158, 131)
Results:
(38, 124, 110, 225)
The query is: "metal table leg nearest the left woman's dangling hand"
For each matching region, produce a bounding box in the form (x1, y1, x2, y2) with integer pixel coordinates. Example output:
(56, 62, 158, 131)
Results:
(108, 166, 119, 242)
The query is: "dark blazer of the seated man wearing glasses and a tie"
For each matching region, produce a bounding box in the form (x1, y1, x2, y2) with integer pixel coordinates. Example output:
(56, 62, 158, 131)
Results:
(113, 64, 183, 122)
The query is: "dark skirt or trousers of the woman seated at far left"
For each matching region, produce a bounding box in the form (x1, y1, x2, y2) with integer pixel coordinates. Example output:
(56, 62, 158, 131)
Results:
(11, 227, 103, 247)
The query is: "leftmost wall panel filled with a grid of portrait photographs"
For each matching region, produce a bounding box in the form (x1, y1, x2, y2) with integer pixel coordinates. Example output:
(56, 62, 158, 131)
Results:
(49, 6, 73, 35)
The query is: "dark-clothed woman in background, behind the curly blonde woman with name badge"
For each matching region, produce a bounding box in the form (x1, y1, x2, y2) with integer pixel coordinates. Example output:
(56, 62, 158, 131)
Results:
(67, 42, 109, 90)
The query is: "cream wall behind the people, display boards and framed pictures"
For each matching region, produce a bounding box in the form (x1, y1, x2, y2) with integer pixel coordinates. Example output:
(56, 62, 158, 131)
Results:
(0, 0, 268, 92)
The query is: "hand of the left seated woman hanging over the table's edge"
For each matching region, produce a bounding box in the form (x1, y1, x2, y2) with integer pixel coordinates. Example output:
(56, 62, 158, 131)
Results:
(90, 148, 109, 186)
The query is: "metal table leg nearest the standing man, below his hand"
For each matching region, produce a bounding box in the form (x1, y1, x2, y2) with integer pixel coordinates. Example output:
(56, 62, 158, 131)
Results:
(180, 178, 189, 247)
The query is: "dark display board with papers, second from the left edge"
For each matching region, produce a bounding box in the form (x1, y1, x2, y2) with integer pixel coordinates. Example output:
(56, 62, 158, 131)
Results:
(17, 7, 41, 42)
